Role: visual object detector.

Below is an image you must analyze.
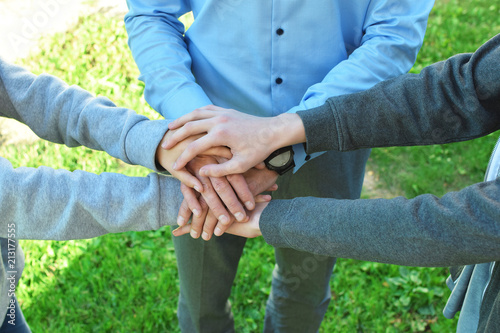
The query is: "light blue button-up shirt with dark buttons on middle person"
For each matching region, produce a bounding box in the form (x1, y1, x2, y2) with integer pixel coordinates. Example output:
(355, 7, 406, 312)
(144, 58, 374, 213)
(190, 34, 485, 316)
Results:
(125, 0, 434, 166)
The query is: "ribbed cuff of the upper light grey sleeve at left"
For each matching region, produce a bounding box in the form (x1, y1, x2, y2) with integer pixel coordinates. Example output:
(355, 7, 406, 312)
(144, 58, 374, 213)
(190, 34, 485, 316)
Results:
(125, 119, 170, 172)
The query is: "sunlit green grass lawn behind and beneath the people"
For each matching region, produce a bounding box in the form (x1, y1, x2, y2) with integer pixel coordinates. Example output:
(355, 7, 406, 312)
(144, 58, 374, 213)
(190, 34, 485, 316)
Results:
(0, 0, 500, 332)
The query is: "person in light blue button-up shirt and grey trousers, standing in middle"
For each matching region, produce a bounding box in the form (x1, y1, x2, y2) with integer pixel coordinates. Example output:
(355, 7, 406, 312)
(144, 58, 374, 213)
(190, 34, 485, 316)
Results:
(125, 0, 434, 332)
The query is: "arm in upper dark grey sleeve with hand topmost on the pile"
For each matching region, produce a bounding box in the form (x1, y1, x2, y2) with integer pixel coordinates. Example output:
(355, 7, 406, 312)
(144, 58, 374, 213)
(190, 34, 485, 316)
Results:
(167, 35, 500, 175)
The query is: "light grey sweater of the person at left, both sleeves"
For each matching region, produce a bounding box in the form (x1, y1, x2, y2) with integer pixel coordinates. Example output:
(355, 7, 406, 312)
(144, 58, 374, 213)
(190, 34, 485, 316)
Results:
(0, 60, 182, 240)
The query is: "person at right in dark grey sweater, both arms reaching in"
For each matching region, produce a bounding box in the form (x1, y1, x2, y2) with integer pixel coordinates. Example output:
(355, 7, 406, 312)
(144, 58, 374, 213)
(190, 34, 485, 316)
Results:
(167, 35, 500, 333)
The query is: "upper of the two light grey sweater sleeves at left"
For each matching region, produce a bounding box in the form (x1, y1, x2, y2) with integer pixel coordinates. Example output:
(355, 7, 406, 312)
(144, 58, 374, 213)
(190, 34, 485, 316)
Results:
(0, 59, 168, 170)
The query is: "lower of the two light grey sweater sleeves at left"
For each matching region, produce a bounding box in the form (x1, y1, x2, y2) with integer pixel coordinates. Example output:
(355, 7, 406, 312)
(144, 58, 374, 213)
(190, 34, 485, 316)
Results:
(0, 158, 182, 240)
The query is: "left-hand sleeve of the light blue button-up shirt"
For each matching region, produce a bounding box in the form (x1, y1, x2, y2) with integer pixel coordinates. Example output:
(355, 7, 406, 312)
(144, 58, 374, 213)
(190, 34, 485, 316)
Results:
(125, 0, 212, 119)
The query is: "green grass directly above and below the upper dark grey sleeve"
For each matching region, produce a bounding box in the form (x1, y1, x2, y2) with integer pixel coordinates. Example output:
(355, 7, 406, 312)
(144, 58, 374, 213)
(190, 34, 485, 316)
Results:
(369, 0, 500, 198)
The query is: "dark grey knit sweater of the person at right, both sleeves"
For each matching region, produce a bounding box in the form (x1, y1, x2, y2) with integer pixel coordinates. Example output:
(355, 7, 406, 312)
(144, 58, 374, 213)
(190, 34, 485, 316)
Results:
(260, 35, 500, 332)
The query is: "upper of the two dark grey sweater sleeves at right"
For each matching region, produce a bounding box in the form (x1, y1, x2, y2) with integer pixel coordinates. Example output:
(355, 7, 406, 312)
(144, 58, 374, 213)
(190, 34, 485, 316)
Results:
(298, 35, 500, 153)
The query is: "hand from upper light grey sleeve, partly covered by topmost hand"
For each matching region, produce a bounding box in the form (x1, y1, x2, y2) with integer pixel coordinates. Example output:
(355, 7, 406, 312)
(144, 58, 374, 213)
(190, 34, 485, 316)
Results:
(156, 130, 231, 192)
